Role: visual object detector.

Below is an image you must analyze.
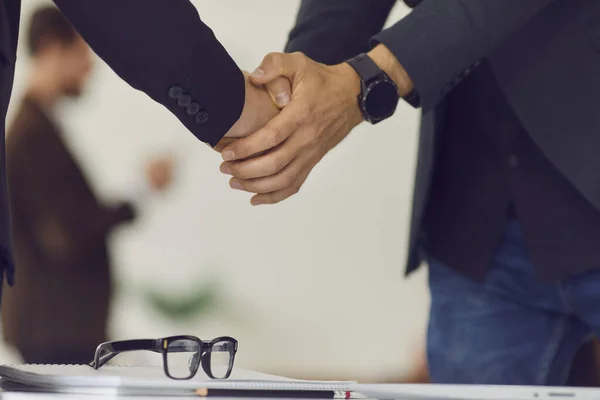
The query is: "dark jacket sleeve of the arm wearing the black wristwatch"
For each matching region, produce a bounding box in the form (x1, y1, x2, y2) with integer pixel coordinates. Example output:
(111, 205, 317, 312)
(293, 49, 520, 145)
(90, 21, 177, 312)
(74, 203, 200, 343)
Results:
(373, 0, 556, 112)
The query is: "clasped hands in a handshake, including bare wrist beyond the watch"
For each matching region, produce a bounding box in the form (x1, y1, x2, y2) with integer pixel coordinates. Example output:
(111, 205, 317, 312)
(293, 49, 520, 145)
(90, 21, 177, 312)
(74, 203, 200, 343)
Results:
(215, 45, 411, 205)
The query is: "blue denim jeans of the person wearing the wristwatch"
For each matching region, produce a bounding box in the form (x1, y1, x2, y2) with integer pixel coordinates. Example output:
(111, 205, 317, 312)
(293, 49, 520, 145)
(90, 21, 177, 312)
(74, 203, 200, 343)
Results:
(427, 220, 600, 386)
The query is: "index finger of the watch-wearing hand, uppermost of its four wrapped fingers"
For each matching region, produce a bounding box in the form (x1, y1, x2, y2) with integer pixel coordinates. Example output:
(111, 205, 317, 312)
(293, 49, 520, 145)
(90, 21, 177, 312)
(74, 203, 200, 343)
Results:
(221, 103, 299, 161)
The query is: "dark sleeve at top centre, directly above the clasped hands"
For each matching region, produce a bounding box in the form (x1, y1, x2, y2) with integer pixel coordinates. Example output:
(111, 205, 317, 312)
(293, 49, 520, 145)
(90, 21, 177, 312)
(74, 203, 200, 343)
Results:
(285, 0, 395, 65)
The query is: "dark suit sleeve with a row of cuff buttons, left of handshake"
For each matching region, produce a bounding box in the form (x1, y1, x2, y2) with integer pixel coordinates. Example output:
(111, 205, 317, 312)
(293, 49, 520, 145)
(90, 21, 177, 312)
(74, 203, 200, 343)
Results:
(54, 0, 245, 146)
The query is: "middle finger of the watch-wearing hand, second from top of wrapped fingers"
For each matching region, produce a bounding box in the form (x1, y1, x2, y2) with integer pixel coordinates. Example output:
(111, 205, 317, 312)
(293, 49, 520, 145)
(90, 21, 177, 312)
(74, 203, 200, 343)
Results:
(221, 126, 304, 179)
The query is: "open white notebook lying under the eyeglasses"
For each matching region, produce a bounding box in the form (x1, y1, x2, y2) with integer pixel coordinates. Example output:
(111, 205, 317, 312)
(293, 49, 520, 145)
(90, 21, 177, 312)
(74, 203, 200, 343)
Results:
(0, 364, 353, 397)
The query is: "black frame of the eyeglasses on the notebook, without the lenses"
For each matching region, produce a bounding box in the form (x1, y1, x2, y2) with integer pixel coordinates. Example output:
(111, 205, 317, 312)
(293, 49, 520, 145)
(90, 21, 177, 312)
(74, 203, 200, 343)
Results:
(88, 335, 238, 380)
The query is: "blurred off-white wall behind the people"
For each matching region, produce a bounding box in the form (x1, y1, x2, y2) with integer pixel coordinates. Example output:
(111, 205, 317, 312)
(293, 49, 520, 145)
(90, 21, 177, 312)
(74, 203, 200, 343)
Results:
(2, 0, 428, 380)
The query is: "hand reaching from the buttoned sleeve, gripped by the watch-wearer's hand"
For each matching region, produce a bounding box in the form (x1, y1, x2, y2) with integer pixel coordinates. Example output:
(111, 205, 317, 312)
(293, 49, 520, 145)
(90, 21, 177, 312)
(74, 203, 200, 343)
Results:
(215, 72, 287, 151)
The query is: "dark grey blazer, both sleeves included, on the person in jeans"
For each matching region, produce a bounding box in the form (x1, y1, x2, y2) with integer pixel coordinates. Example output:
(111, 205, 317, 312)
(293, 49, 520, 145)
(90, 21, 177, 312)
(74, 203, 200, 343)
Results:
(286, 0, 600, 273)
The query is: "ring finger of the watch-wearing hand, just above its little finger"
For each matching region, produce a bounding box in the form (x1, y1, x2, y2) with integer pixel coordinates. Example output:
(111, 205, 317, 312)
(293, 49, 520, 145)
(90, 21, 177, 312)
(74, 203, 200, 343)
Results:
(229, 156, 309, 193)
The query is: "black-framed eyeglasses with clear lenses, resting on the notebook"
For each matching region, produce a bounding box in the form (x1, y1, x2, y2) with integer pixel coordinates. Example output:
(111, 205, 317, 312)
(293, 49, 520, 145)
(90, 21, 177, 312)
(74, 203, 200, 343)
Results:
(88, 336, 238, 379)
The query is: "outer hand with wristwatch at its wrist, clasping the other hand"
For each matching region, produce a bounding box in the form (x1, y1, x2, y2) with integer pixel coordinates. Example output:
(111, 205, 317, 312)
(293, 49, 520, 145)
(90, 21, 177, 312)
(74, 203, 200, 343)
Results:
(221, 53, 362, 205)
